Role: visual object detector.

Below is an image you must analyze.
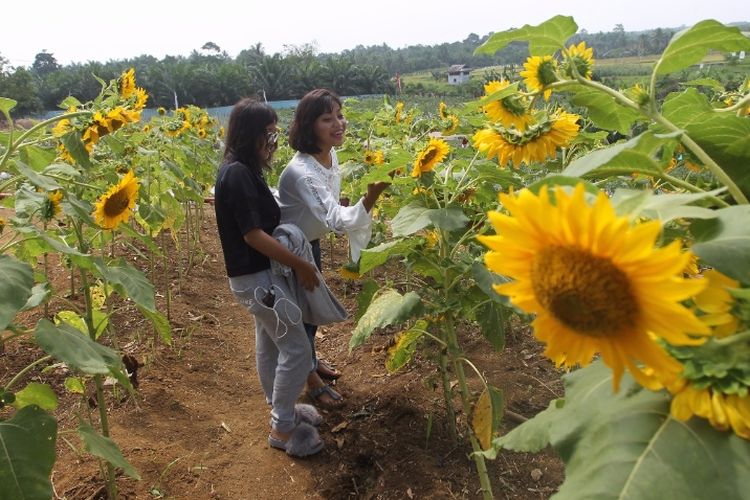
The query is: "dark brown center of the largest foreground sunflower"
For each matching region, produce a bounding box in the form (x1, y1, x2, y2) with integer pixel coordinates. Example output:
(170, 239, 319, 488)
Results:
(531, 246, 639, 337)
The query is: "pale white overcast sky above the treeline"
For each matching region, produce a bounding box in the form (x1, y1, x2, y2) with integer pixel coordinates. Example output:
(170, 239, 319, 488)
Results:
(0, 0, 750, 67)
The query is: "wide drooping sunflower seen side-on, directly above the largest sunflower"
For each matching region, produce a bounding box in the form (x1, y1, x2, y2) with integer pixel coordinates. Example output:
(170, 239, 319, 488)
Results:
(473, 112, 579, 168)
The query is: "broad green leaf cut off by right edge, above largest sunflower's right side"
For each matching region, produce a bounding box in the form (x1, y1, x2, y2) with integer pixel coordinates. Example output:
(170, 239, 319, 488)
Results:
(690, 205, 750, 284)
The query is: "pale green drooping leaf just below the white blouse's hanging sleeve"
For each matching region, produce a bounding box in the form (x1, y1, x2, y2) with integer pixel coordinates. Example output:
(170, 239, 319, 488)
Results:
(349, 288, 420, 352)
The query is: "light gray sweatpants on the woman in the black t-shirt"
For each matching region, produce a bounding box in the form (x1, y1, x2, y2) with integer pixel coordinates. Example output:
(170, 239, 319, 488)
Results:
(229, 270, 311, 432)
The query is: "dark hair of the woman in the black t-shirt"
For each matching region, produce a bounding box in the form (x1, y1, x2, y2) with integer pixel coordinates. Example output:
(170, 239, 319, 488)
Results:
(224, 97, 279, 172)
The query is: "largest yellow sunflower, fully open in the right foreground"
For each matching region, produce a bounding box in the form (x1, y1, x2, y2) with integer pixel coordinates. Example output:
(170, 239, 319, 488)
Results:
(478, 184, 709, 391)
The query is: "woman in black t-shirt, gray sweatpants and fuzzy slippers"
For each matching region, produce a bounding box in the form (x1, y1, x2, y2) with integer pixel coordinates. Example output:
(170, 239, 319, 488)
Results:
(215, 99, 323, 456)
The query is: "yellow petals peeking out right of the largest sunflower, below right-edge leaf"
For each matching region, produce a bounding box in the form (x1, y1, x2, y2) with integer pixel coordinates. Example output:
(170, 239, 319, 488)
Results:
(693, 269, 740, 337)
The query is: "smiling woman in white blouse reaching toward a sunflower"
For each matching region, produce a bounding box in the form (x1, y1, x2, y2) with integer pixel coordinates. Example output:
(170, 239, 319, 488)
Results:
(278, 89, 388, 408)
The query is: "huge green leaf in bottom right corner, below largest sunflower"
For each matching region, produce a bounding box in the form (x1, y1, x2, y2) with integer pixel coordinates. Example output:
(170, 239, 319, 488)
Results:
(487, 361, 750, 500)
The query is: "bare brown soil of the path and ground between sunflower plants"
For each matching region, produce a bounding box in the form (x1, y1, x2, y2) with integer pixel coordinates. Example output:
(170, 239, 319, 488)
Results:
(0, 206, 563, 500)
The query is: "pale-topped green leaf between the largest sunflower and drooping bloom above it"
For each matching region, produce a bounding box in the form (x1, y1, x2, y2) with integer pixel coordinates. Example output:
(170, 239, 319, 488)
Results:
(562, 132, 679, 177)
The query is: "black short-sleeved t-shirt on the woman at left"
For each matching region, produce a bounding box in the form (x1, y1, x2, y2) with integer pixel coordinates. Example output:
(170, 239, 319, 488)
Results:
(214, 162, 281, 278)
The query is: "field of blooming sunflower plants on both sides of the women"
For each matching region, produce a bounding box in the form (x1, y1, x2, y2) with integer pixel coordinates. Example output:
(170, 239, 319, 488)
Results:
(0, 16, 750, 500)
